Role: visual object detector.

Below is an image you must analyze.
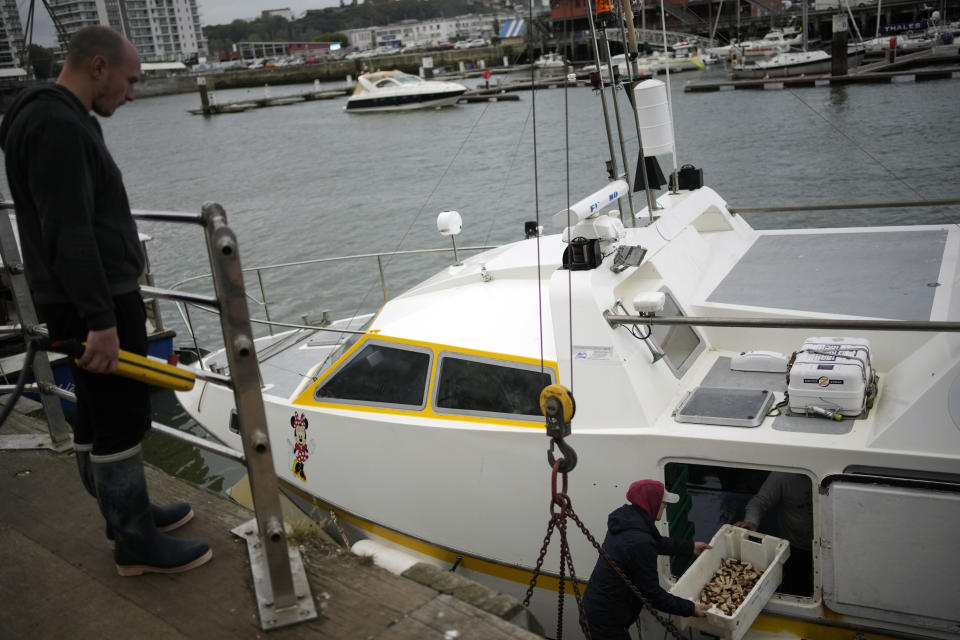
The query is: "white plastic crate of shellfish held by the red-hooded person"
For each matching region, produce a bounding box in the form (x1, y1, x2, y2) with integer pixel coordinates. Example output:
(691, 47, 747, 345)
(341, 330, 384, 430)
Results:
(670, 524, 790, 640)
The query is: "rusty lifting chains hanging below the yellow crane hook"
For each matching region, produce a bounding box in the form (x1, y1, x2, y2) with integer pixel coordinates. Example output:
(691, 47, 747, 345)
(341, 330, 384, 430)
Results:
(523, 458, 686, 640)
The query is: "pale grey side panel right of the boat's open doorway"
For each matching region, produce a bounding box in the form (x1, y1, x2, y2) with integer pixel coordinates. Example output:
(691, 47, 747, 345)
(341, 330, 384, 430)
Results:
(820, 479, 960, 633)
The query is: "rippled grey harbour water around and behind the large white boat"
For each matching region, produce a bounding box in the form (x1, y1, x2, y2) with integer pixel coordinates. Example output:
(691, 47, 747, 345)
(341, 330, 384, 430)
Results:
(3, 68, 960, 491)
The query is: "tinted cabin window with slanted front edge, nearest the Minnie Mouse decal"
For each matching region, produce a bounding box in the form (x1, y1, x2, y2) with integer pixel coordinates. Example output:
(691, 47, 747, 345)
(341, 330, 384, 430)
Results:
(314, 342, 431, 409)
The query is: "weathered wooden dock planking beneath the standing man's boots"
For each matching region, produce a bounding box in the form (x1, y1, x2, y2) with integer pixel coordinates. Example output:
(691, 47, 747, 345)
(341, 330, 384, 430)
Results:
(0, 402, 539, 640)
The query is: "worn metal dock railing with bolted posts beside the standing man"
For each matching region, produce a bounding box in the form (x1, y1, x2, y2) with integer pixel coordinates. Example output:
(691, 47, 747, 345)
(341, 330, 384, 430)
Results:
(0, 202, 317, 630)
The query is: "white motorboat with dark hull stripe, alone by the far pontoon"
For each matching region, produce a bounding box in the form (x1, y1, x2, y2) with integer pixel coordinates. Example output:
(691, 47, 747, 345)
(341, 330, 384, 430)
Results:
(345, 71, 467, 113)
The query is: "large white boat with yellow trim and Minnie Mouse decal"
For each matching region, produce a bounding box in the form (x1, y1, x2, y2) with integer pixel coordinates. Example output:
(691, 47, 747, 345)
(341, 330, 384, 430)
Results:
(178, 81, 960, 638)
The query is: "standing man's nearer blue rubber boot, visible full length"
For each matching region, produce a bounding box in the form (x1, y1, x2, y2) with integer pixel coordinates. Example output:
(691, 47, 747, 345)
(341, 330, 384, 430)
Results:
(90, 445, 213, 576)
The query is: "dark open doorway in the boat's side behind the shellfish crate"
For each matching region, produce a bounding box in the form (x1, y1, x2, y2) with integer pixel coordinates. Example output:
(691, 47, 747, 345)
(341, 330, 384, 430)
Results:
(665, 462, 814, 597)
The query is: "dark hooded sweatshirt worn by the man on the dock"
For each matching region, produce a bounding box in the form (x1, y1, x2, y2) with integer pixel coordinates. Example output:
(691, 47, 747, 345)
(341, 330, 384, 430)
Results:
(0, 85, 144, 330)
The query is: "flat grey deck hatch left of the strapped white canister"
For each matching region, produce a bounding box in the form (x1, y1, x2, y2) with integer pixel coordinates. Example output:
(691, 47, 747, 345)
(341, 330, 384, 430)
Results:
(674, 387, 774, 427)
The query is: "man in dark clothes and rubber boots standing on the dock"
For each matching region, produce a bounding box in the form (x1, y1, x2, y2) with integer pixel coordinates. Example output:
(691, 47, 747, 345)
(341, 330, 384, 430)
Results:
(0, 26, 213, 576)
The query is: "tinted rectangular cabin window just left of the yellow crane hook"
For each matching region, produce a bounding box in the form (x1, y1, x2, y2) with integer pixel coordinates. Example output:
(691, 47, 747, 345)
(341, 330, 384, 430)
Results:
(434, 354, 553, 420)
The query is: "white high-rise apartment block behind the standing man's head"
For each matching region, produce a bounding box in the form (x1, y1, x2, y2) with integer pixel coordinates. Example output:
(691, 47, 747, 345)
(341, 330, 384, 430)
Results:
(48, 0, 207, 62)
